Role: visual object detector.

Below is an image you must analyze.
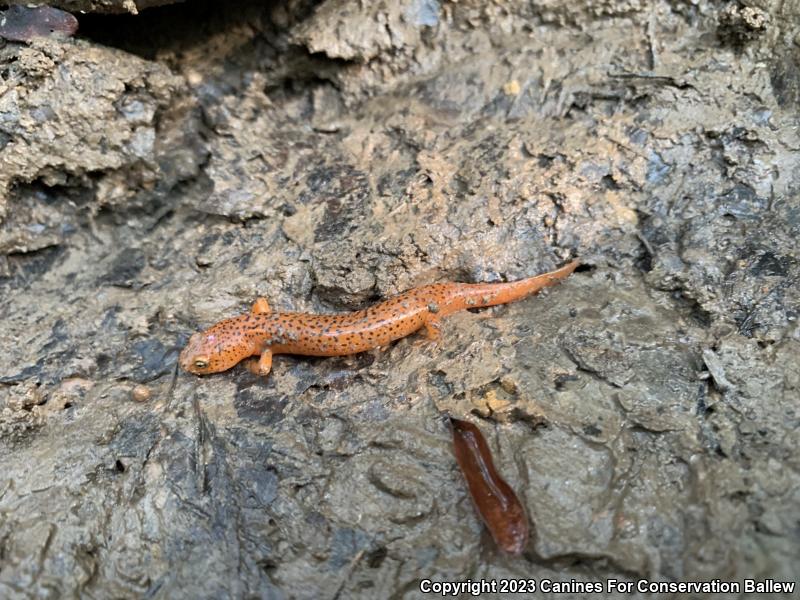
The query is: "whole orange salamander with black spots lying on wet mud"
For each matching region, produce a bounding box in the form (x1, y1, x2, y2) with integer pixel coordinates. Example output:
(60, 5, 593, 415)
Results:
(179, 261, 578, 375)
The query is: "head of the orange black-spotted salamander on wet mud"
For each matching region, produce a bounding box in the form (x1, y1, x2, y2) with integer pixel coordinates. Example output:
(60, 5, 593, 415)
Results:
(178, 317, 256, 375)
